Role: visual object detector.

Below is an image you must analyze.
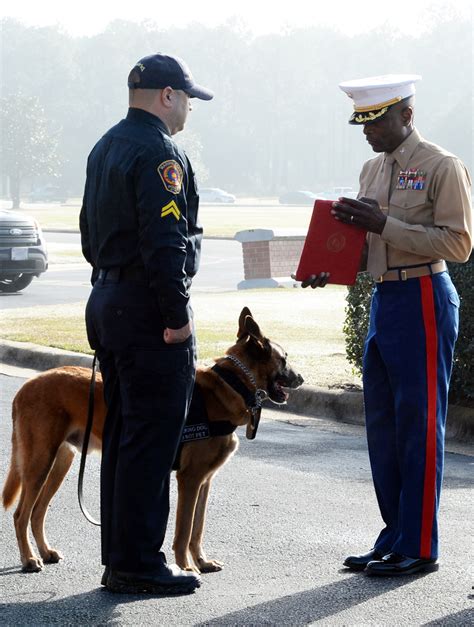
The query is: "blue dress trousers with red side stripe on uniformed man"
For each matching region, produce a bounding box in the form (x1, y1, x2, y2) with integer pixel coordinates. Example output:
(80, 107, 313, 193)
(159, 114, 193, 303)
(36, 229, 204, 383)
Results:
(363, 272, 459, 559)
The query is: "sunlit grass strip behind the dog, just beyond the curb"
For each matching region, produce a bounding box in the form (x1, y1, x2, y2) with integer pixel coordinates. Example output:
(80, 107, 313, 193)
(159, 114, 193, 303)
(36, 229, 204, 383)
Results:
(0, 286, 360, 387)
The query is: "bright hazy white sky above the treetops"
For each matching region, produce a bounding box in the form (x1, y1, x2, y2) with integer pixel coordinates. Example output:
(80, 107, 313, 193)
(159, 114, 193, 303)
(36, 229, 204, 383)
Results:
(2, 0, 472, 35)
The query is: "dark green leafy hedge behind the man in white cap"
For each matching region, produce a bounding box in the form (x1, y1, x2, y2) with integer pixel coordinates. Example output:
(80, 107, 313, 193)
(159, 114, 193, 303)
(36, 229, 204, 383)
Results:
(343, 255, 474, 407)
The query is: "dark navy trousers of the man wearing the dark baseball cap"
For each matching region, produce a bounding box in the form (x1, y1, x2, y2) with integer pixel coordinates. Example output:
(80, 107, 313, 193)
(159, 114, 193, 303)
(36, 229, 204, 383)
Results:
(86, 278, 196, 573)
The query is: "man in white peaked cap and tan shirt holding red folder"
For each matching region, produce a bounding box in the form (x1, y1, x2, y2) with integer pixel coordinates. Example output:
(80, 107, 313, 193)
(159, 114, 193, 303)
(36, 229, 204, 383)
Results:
(303, 75, 472, 575)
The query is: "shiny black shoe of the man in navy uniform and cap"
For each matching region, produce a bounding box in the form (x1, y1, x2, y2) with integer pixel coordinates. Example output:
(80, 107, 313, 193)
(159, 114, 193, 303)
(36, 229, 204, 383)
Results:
(104, 564, 201, 594)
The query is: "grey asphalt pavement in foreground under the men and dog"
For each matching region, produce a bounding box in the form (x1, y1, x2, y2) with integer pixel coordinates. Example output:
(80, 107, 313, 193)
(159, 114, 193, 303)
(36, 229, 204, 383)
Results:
(0, 371, 474, 627)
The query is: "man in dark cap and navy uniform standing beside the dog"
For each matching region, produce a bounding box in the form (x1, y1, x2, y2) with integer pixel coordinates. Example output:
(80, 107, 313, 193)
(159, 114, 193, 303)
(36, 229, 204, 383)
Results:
(80, 53, 213, 593)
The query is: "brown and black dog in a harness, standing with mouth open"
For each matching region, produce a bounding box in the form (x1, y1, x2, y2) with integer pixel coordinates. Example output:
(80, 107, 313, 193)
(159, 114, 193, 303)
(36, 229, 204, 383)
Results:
(3, 307, 303, 572)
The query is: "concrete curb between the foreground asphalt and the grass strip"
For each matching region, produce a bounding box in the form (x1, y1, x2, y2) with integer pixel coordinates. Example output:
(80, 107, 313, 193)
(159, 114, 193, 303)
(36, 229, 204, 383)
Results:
(0, 340, 474, 442)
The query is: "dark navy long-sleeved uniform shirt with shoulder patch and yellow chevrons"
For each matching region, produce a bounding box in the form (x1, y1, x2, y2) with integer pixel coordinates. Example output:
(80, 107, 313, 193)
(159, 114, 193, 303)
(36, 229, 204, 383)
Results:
(80, 108, 202, 329)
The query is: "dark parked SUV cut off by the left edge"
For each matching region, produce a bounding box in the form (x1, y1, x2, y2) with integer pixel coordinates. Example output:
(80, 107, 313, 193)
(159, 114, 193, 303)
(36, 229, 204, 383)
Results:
(0, 209, 48, 292)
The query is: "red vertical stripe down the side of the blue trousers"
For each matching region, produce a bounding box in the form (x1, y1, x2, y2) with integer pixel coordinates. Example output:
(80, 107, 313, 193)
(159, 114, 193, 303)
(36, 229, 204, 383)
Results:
(420, 276, 438, 558)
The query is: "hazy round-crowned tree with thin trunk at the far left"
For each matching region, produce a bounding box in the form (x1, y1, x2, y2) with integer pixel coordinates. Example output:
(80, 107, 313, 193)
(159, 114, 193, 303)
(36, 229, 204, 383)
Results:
(0, 93, 61, 209)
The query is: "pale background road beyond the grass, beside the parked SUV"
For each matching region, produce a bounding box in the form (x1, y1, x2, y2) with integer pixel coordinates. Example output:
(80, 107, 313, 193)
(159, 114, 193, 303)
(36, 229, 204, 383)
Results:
(0, 233, 244, 309)
